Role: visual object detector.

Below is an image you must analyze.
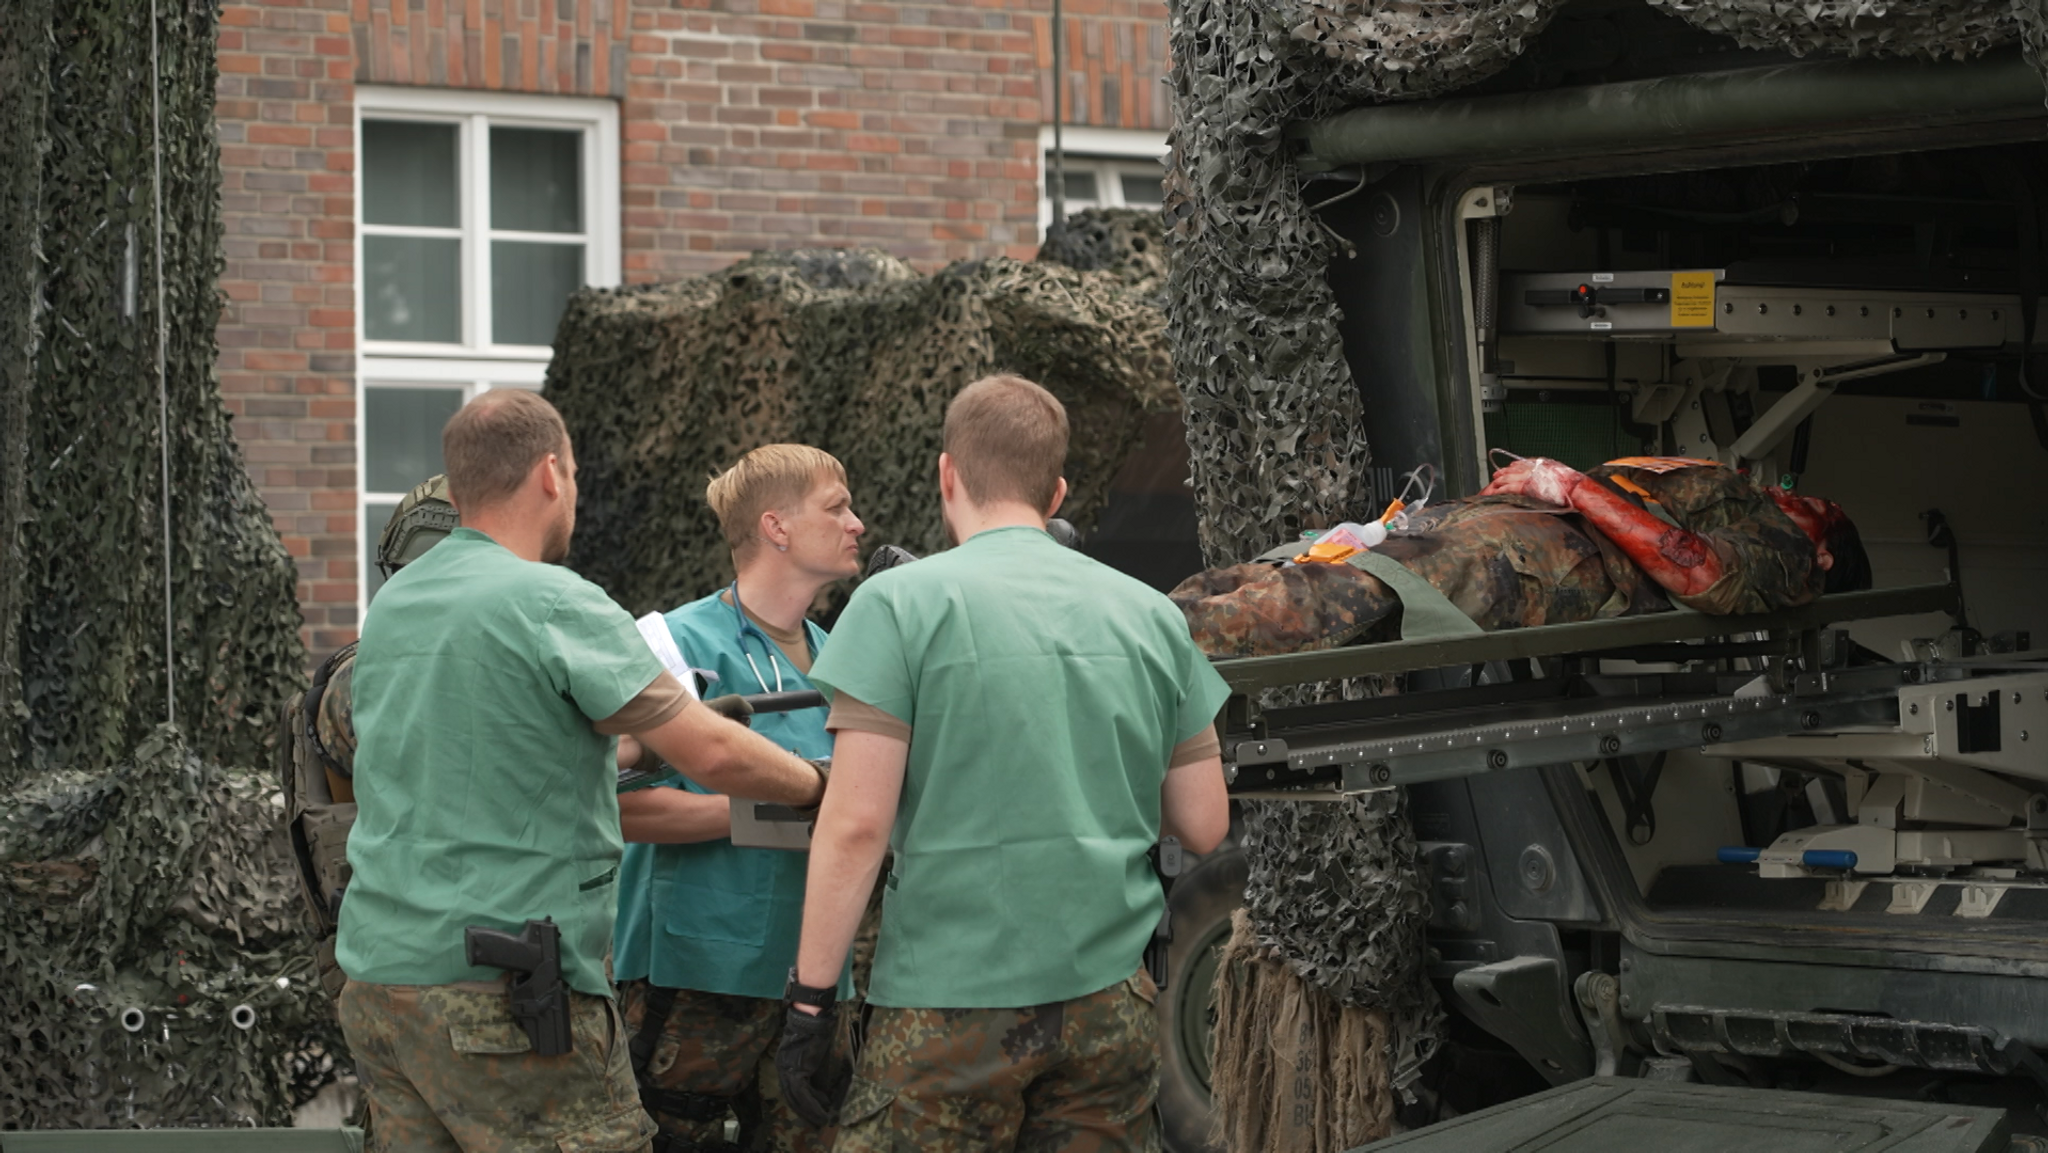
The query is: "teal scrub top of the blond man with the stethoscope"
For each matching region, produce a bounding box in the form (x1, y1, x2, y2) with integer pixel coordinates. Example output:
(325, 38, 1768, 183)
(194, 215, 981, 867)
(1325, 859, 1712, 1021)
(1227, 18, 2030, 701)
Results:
(614, 594, 854, 999)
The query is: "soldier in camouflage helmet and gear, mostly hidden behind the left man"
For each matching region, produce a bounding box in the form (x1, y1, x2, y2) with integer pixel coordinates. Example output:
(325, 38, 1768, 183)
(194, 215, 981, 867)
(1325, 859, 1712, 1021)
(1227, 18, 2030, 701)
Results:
(279, 477, 459, 995)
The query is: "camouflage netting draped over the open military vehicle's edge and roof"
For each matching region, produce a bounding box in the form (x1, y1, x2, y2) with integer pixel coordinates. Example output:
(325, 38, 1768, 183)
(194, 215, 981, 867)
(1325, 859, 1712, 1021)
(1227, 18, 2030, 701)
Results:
(1163, 0, 2048, 1153)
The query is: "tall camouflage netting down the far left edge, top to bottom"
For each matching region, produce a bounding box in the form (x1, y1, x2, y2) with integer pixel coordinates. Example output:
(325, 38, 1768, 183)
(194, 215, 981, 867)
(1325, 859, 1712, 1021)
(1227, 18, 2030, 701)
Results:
(0, 0, 336, 1128)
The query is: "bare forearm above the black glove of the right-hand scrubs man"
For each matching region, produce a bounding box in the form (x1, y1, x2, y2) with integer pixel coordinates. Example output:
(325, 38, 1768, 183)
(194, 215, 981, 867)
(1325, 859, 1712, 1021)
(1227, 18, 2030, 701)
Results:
(797, 729, 909, 995)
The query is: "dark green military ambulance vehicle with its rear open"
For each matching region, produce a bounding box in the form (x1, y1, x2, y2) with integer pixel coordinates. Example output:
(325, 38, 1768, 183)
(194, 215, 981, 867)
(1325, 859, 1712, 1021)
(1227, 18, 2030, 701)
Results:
(1163, 0, 2048, 1151)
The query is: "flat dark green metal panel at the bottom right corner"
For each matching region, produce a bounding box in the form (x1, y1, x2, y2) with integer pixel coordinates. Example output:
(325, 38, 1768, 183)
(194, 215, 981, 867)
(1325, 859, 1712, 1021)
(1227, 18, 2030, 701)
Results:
(1362, 1077, 2011, 1153)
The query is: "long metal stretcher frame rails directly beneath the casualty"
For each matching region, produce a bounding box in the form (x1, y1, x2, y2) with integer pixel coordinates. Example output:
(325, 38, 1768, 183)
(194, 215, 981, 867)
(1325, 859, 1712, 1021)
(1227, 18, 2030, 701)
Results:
(1217, 586, 1956, 799)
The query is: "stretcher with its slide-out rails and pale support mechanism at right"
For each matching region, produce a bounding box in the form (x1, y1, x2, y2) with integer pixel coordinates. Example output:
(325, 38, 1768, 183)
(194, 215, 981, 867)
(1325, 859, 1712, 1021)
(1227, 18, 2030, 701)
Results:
(1217, 586, 2048, 880)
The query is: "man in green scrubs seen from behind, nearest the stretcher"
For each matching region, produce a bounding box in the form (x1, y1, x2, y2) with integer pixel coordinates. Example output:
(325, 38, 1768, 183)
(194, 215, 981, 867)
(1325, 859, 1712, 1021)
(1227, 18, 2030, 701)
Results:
(776, 377, 1229, 1153)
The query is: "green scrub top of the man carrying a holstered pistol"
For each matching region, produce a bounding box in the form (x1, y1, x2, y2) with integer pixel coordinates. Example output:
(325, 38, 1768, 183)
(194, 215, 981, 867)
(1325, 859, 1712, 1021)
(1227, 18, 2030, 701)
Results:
(334, 528, 662, 997)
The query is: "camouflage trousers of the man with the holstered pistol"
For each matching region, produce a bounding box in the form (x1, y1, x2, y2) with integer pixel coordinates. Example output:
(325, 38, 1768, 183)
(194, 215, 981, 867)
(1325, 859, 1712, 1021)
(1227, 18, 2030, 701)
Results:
(338, 981, 653, 1153)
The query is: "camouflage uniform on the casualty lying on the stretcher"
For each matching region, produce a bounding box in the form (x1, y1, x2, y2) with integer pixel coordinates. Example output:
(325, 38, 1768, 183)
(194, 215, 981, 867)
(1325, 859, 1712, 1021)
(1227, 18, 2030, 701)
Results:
(1169, 461, 1853, 655)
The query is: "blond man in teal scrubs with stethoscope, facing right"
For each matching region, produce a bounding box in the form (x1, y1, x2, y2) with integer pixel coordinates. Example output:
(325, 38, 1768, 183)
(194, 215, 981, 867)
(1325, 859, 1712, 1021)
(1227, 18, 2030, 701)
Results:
(616, 444, 864, 1153)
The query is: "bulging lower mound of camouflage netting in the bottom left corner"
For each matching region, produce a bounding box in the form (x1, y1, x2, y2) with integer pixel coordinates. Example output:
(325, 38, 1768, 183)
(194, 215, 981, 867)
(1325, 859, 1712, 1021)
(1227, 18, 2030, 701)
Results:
(0, 725, 346, 1128)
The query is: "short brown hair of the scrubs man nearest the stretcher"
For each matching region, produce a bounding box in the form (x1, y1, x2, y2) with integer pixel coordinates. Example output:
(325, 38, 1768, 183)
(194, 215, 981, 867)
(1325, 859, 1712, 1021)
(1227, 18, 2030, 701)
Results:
(946, 375, 1067, 510)
